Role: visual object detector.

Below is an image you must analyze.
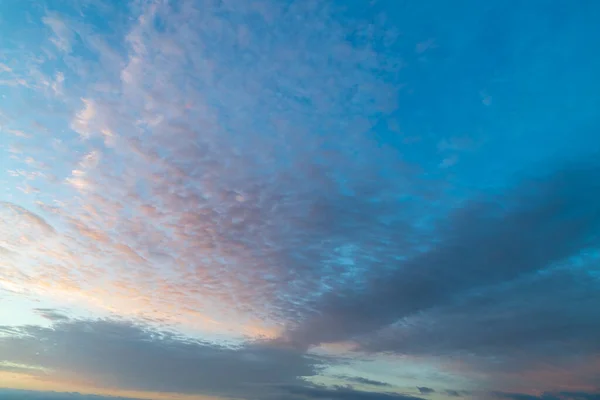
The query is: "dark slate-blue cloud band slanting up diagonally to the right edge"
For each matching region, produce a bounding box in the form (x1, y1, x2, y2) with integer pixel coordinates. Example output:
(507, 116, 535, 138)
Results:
(286, 167, 600, 352)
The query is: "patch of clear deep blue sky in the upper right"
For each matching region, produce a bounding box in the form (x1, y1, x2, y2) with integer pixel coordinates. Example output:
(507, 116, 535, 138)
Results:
(375, 1, 600, 190)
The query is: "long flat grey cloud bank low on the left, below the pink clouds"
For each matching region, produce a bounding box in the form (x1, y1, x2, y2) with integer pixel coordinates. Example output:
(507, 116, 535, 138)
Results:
(0, 319, 327, 398)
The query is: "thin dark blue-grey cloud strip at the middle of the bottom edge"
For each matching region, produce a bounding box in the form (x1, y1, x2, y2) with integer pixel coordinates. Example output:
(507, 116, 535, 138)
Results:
(282, 385, 423, 400)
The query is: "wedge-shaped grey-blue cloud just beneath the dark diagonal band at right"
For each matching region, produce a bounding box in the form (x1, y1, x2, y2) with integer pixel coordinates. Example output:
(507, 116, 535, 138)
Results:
(364, 268, 600, 358)
